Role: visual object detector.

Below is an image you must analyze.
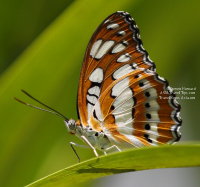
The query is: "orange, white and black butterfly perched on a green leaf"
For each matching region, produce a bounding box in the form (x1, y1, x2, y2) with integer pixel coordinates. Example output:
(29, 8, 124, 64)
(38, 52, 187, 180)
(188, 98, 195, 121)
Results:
(15, 11, 182, 162)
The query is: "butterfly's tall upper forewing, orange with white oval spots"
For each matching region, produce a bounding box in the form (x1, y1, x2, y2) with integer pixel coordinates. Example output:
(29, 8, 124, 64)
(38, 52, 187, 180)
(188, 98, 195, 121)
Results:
(77, 12, 155, 130)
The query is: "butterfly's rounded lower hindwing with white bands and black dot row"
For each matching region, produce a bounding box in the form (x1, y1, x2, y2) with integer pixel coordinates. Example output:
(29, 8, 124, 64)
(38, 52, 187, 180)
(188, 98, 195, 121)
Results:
(94, 68, 181, 147)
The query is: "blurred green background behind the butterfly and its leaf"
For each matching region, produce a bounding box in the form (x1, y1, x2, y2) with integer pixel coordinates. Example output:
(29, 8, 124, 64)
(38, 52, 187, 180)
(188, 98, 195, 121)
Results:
(0, 0, 200, 187)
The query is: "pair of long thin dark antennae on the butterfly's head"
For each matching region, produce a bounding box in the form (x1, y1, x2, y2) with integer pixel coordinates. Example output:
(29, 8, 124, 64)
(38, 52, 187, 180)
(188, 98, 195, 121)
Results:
(13, 90, 69, 121)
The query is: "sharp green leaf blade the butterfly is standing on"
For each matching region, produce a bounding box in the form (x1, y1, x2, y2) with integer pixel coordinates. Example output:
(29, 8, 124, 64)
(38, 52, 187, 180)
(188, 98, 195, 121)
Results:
(26, 145, 200, 187)
